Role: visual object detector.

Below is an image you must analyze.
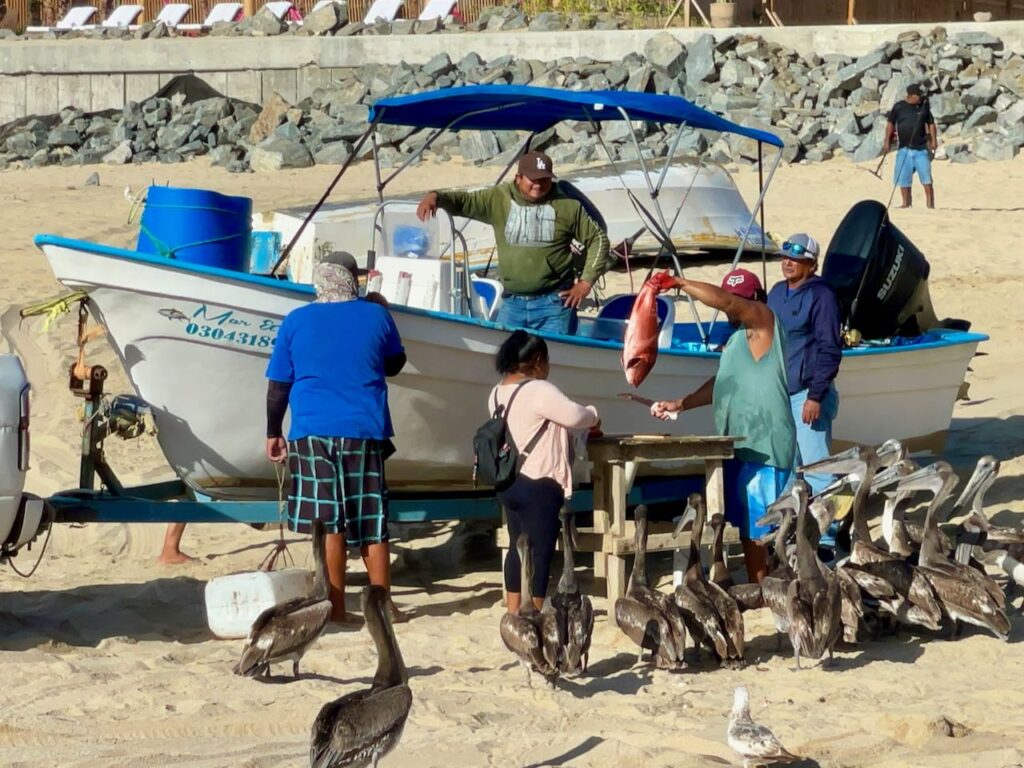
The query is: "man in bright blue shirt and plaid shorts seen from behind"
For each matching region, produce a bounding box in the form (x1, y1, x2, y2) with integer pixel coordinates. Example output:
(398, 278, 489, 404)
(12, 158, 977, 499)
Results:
(266, 253, 406, 622)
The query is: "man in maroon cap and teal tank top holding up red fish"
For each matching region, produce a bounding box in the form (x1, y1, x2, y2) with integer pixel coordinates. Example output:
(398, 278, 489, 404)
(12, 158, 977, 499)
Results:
(650, 269, 797, 582)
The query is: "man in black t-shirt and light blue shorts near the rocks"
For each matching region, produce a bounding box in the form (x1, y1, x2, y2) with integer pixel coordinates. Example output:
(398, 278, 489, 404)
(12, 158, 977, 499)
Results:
(882, 83, 938, 208)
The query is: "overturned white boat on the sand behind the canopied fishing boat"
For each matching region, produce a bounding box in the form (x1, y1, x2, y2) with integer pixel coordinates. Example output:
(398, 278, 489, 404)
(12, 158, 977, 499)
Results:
(253, 159, 778, 283)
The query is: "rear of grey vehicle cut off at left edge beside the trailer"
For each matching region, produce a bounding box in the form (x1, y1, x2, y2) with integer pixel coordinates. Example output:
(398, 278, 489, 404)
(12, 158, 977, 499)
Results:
(0, 354, 44, 559)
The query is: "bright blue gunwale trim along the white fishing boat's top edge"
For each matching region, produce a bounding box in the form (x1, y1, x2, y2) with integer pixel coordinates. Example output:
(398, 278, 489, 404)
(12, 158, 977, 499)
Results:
(33, 234, 988, 358)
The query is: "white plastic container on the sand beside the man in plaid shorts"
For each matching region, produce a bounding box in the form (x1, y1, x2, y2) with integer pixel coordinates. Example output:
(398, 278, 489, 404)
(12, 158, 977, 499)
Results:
(200, 568, 313, 639)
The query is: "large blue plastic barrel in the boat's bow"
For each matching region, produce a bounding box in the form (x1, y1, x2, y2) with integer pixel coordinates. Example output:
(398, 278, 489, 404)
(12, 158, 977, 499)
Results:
(137, 186, 253, 272)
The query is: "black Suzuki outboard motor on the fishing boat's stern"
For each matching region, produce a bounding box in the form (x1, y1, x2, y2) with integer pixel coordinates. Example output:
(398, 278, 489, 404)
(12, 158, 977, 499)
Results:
(821, 200, 971, 339)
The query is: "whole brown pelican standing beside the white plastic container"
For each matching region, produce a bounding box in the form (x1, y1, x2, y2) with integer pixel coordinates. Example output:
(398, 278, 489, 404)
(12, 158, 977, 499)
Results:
(233, 520, 331, 677)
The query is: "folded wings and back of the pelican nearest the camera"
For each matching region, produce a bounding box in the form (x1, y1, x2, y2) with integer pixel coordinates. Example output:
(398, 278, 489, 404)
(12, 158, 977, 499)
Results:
(309, 685, 413, 768)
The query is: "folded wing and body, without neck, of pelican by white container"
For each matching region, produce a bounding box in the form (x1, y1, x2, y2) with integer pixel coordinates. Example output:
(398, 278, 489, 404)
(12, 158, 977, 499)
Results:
(234, 597, 331, 676)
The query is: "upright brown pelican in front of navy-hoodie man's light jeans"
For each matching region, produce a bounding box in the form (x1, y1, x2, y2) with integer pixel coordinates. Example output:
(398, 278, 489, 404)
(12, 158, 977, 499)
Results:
(785, 483, 843, 670)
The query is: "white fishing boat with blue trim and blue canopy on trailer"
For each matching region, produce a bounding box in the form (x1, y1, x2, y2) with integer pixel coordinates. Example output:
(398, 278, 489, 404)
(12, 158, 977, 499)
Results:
(36, 86, 986, 499)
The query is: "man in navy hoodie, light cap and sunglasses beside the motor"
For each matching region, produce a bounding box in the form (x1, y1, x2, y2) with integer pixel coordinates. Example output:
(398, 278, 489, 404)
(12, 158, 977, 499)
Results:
(768, 232, 843, 494)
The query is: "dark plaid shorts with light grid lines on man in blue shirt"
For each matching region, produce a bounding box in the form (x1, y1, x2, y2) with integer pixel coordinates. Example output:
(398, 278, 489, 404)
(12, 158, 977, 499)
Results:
(288, 435, 388, 547)
